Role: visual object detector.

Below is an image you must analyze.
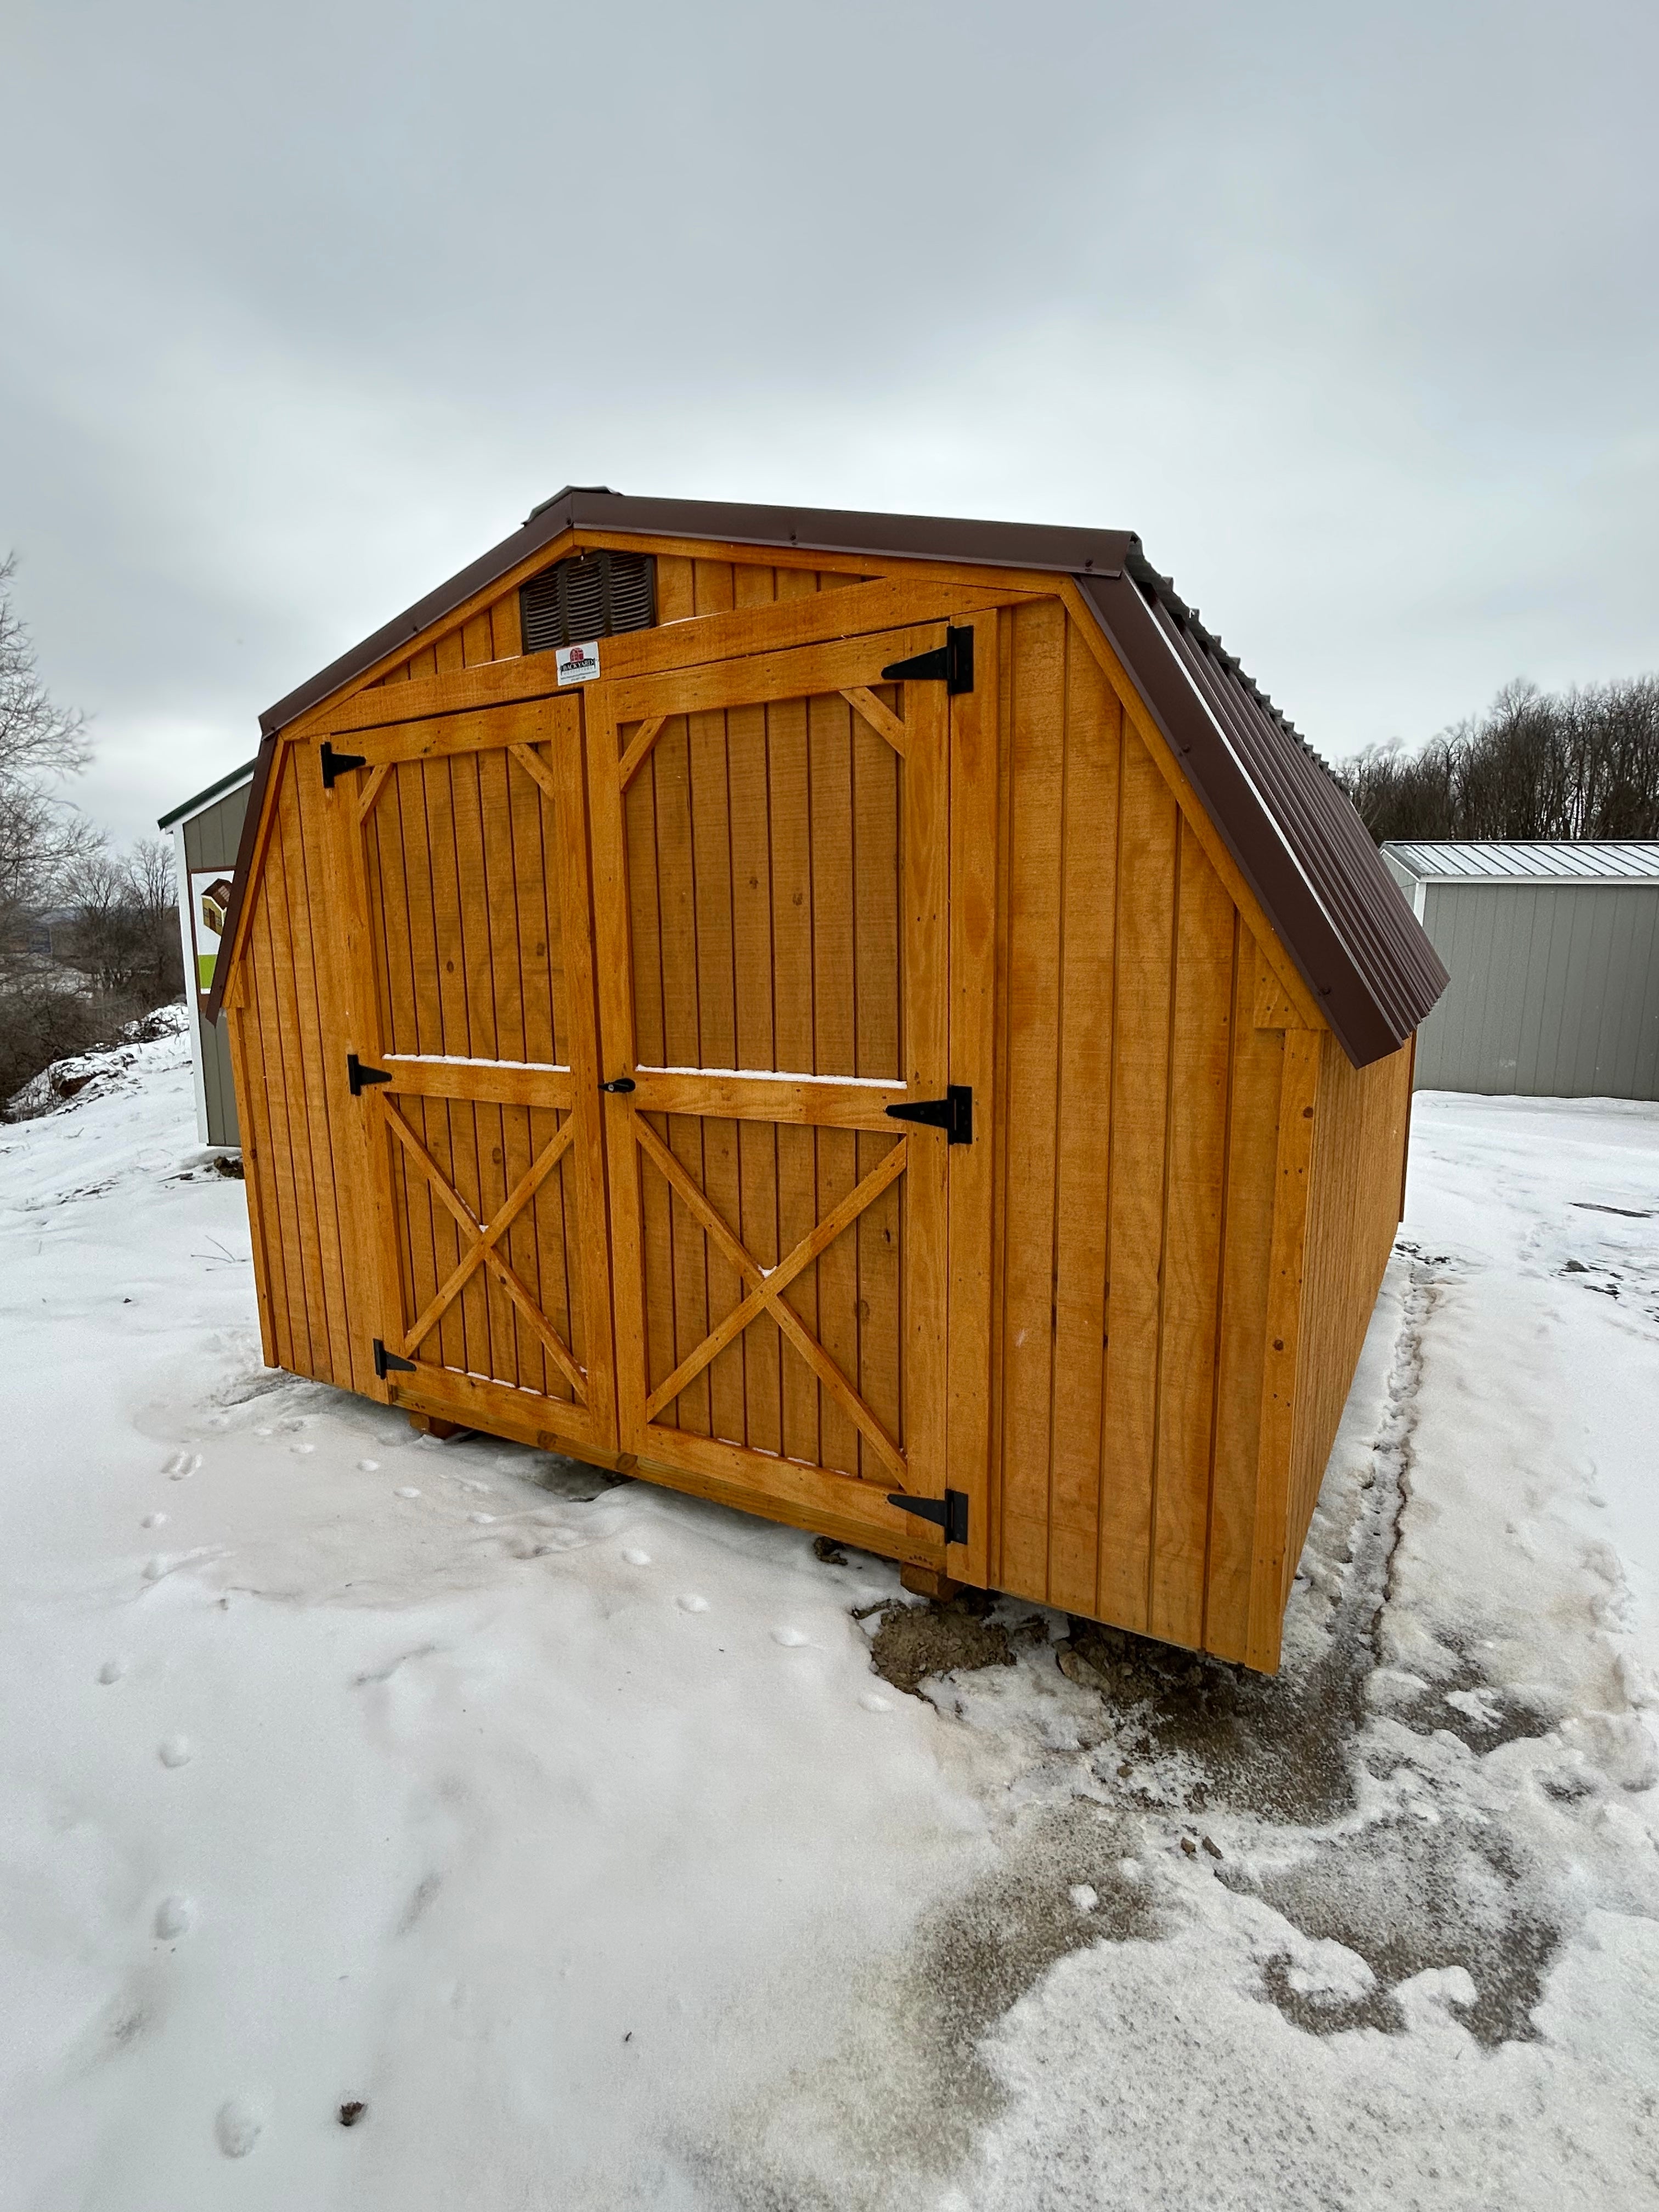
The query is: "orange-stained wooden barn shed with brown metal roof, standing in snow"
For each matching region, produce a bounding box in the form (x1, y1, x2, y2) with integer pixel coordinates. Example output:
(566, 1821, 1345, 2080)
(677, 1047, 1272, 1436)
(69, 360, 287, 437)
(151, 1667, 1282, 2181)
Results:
(215, 489, 1444, 1668)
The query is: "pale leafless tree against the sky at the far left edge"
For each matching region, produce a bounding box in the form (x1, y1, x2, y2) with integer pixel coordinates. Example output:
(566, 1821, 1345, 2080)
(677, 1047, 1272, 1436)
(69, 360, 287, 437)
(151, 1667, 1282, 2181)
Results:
(0, 555, 93, 938)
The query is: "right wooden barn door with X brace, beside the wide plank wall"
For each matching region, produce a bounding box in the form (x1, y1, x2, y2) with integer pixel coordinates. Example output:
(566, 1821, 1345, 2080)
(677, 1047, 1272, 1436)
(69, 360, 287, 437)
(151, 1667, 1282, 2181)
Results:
(584, 624, 989, 1575)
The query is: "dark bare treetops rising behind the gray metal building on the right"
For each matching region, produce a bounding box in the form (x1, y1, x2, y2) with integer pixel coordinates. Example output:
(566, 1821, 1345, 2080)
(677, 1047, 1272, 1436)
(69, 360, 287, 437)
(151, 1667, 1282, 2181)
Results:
(1336, 677, 1659, 845)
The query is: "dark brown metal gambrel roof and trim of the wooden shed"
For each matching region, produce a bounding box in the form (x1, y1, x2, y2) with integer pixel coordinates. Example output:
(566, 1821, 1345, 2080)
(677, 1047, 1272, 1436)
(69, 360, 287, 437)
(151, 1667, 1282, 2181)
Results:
(208, 498, 1449, 1066)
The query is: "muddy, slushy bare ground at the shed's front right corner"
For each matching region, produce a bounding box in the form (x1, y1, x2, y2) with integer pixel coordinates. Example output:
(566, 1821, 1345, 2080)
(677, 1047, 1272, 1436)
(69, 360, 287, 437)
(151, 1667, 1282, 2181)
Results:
(845, 1254, 1659, 2064)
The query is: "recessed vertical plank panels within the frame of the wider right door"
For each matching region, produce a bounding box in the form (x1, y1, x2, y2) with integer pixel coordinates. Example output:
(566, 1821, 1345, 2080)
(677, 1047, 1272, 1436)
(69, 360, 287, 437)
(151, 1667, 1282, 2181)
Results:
(622, 676, 905, 1480)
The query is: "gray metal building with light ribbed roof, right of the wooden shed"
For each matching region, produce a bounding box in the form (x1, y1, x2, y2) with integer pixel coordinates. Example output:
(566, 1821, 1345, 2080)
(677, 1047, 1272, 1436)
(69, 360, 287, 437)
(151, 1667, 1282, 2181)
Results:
(1383, 843, 1659, 1099)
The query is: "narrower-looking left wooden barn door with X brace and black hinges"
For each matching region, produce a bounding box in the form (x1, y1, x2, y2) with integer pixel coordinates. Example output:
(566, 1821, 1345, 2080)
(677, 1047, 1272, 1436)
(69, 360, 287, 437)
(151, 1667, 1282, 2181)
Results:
(321, 688, 617, 1451)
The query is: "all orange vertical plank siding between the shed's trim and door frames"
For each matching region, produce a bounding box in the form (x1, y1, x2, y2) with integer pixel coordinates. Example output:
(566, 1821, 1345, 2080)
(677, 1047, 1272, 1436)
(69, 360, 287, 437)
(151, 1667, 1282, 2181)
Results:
(232, 557, 1409, 1666)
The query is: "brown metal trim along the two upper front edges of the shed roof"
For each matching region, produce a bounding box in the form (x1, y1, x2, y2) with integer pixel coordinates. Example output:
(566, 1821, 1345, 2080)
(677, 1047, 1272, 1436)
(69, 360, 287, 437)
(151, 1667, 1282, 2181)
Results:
(259, 484, 1139, 735)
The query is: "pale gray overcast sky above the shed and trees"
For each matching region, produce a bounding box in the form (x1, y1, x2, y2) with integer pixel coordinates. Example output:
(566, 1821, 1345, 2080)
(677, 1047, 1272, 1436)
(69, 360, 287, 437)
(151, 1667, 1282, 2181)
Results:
(0, 0, 1659, 838)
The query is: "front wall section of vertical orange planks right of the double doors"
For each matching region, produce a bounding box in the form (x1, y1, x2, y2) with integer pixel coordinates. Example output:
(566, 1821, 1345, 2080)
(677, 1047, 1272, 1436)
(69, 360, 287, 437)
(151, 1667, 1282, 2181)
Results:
(991, 602, 1309, 1657)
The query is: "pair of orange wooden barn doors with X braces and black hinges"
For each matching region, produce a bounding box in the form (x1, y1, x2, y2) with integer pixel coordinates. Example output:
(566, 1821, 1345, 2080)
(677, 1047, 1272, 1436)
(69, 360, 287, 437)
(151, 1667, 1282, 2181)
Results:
(323, 597, 995, 1575)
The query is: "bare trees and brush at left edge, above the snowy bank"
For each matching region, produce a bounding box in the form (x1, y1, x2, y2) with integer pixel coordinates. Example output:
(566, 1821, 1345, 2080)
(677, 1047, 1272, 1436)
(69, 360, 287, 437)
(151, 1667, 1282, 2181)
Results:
(0, 557, 184, 1113)
